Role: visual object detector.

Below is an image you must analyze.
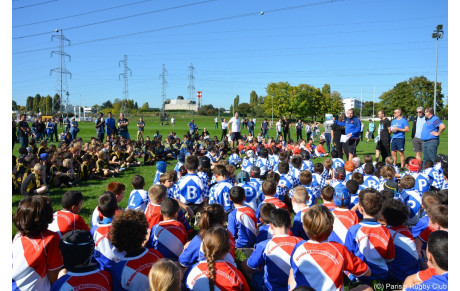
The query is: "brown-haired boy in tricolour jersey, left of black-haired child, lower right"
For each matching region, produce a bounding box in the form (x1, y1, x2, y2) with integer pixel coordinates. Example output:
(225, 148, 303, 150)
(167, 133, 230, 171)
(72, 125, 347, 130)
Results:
(345, 189, 395, 282)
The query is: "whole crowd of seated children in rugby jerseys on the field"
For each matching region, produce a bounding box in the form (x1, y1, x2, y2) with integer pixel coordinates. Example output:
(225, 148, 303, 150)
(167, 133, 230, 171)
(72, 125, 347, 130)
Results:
(13, 126, 448, 290)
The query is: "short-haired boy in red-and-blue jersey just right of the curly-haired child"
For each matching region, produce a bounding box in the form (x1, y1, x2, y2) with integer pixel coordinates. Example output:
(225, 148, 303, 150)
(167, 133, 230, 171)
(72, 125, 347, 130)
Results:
(147, 198, 188, 261)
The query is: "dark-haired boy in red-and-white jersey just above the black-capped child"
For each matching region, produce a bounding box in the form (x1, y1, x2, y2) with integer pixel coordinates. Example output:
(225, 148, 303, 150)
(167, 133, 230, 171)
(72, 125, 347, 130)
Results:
(48, 190, 89, 237)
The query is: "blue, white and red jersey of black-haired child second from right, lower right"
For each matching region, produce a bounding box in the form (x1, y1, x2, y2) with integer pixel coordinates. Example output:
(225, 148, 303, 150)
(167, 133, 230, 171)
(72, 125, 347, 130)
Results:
(388, 225, 419, 281)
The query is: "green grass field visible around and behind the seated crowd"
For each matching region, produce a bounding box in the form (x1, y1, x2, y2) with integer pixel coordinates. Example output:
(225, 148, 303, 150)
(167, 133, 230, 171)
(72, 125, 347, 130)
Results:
(12, 114, 448, 289)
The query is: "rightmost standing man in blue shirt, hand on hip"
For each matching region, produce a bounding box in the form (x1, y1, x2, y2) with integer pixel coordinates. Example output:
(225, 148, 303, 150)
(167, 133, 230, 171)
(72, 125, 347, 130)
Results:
(421, 107, 446, 166)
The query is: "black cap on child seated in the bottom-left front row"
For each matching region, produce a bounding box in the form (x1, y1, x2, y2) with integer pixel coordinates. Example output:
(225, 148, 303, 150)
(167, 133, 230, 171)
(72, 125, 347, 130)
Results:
(59, 229, 94, 270)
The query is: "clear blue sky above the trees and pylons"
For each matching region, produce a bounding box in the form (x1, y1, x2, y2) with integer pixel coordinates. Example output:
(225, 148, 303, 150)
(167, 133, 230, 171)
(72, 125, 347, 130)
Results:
(12, 0, 449, 108)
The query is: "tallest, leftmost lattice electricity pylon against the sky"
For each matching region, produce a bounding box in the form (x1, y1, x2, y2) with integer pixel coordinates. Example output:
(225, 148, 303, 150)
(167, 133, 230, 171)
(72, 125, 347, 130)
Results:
(50, 29, 72, 113)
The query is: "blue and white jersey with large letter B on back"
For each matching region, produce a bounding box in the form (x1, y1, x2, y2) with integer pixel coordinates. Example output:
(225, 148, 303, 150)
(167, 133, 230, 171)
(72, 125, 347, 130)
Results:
(174, 174, 209, 204)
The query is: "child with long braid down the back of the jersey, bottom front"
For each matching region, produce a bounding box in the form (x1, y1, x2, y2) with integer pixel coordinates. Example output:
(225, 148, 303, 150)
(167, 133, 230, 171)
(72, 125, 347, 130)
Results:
(184, 226, 249, 291)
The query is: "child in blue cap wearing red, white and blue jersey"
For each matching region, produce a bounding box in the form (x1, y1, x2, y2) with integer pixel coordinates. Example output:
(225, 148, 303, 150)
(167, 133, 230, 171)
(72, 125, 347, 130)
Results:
(329, 185, 359, 245)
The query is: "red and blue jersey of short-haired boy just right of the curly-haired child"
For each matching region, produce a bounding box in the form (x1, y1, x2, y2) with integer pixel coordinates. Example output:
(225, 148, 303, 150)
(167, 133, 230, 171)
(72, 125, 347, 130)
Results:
(147, 220, 188, 261)
